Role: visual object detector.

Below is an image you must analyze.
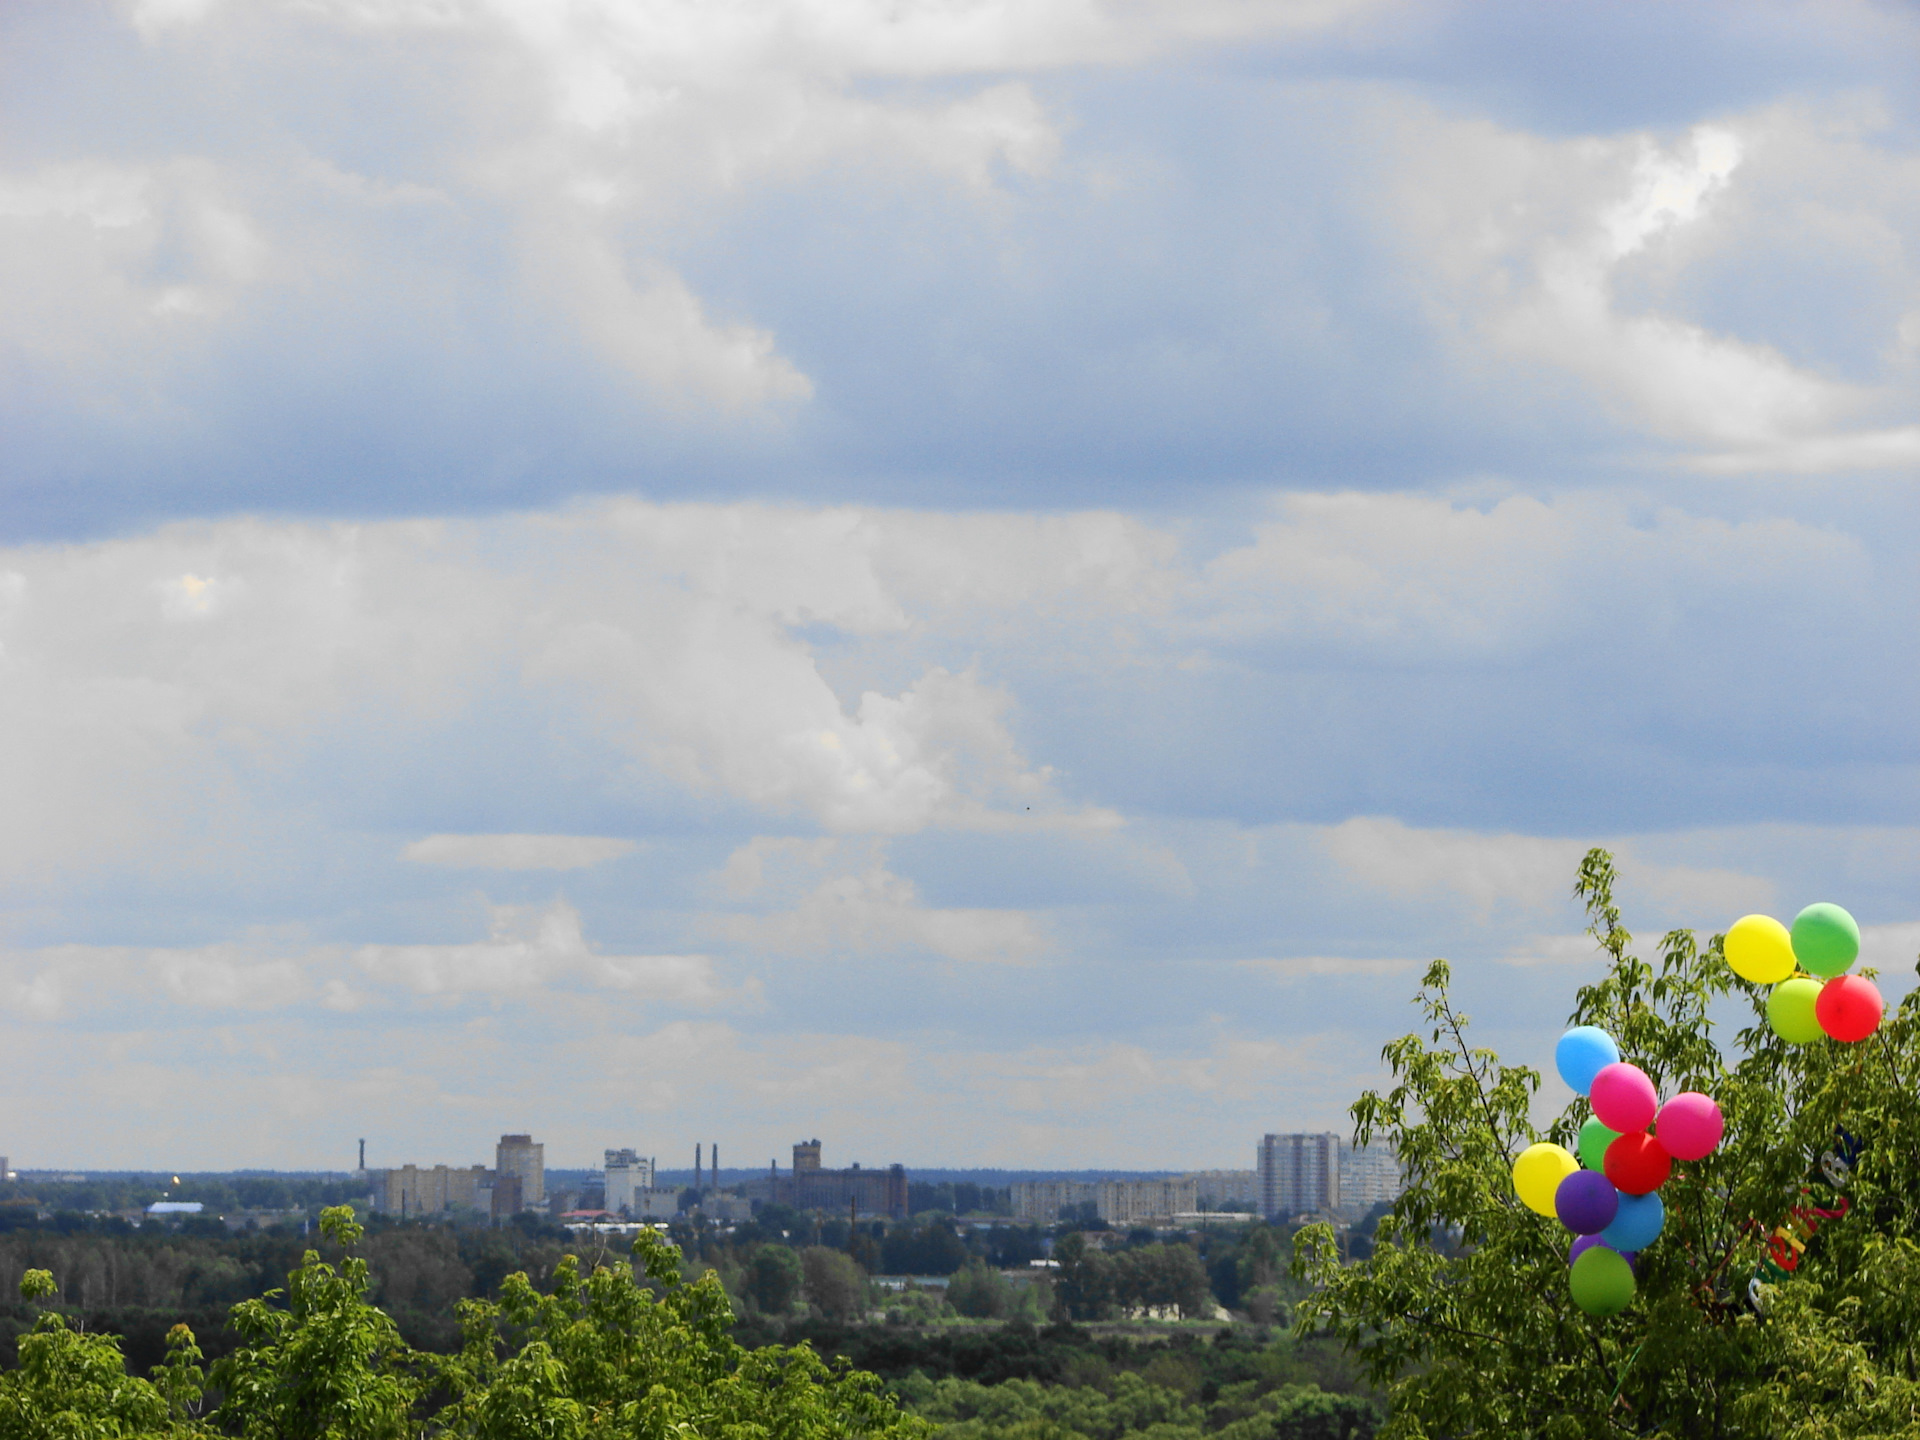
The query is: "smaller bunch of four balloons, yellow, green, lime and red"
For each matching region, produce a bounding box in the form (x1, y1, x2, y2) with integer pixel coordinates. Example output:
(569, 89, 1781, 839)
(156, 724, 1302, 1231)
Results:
(1726, 904, 1885, 1044)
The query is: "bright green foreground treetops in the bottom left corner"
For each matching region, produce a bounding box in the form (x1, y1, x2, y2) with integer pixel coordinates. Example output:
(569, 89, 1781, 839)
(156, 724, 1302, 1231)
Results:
(0, 1206, 925, 1440)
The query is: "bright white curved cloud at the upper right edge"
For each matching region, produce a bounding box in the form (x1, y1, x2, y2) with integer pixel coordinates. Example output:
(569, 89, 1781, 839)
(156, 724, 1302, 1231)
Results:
(1394, 102, 1920, 472)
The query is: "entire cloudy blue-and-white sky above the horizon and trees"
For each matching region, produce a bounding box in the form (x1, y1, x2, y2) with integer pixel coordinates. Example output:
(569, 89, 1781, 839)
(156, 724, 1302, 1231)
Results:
(0, 0, 1920, 1169)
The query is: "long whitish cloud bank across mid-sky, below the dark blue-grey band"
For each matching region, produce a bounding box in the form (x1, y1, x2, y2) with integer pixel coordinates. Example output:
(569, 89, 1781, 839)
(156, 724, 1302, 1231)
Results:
(0, 493, 1882, 890)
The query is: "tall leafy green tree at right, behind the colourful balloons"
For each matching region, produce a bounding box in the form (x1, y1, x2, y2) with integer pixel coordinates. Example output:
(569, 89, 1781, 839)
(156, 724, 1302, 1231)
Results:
(1296, 851, 1920, 1440)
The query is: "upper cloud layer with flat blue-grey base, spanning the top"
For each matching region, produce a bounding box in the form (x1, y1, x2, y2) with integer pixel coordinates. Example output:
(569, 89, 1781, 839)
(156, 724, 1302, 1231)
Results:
(0, 0, 1920, 536)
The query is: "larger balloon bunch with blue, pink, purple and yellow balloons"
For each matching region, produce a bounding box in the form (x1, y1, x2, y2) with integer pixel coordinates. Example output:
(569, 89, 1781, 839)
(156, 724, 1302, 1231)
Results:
(1513, 1025, 1726, 1315)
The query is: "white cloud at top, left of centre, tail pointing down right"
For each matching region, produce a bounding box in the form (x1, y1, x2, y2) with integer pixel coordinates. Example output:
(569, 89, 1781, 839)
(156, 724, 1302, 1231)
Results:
(82, 0, 1380, 424)
